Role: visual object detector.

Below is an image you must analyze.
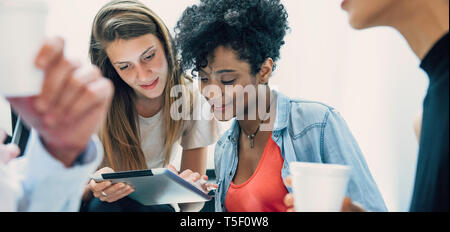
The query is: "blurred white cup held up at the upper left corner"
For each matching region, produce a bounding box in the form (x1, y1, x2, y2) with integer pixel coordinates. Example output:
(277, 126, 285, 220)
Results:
(0, 0, 48, 97)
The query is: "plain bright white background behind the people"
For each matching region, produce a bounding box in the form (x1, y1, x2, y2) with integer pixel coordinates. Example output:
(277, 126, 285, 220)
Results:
(0, 0, 428, 211)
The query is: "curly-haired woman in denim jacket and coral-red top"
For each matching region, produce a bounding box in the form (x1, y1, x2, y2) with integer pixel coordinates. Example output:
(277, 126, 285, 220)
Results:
(175, 0, 386, 212)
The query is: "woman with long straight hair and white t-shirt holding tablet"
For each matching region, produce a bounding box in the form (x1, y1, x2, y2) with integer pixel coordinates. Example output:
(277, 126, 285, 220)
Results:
(85, 0, 218, 211)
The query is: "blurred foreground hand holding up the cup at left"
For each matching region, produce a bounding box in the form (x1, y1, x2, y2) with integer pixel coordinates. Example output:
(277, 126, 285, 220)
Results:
(8, 38, 114, 167)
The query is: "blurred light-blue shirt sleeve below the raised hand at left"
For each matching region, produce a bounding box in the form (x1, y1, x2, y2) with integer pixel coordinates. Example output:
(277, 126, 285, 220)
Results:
(13, 131, 103, 211)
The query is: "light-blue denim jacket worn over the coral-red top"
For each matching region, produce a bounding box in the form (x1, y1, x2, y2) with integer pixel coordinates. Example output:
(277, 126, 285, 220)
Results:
(214, 91, 387, 212)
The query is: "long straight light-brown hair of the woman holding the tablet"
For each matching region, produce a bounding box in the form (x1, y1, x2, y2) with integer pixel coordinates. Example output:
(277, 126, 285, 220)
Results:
(89, 0, 192, 171)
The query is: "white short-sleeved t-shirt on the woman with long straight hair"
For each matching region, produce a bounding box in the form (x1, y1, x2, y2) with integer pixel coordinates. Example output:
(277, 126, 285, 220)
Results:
(139, 92, 219, 169)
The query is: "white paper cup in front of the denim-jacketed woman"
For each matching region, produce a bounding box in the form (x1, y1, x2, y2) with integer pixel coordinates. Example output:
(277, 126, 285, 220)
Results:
(289, 162, 350, 212)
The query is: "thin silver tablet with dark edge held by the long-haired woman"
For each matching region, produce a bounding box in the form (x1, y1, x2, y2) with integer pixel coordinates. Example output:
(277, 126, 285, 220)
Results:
(92, 168, 212, 205)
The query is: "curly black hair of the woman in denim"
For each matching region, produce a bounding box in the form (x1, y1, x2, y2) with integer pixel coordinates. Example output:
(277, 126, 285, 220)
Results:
(175, 0, 289, 75)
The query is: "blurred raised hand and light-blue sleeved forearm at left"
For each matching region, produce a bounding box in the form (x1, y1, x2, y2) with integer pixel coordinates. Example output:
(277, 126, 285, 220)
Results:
(3, 38, 113, 211)
